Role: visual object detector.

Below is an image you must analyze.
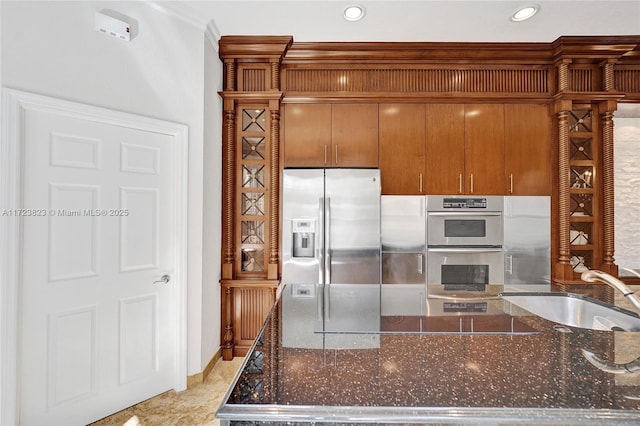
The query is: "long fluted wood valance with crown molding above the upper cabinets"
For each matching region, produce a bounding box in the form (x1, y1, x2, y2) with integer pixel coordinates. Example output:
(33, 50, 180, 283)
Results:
(280, 36, 640, 102)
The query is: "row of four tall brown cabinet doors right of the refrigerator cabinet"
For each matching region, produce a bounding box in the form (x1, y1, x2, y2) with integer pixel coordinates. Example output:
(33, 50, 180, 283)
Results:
(390, 104, 551, 195)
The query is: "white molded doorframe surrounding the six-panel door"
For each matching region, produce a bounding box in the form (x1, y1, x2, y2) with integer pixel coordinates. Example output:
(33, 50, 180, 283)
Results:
(0, 89, 188, 426)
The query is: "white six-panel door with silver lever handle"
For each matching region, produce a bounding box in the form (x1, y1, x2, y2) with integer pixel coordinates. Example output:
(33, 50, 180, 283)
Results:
(1, 90, 188, 425)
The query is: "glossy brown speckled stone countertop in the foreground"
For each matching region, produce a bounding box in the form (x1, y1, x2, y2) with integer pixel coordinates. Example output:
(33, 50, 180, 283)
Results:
(217, 288, 640, 425)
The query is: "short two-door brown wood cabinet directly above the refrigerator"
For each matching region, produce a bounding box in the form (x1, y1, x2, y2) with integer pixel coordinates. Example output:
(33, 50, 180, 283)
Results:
(284, 104, 378, 167)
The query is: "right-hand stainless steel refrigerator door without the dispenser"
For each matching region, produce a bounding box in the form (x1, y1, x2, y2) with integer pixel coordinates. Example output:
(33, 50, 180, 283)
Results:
(324, 169, 380, 285)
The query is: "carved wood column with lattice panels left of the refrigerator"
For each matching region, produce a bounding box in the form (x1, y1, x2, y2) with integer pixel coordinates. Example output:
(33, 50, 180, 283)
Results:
(219, 36, 293, 360)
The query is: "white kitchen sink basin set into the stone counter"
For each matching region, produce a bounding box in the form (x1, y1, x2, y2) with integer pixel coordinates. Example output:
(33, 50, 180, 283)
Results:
(500, 292, 640, 331)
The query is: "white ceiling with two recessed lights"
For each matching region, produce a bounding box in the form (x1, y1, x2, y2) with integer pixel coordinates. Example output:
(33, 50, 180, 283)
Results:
(157, 0, 640, 42)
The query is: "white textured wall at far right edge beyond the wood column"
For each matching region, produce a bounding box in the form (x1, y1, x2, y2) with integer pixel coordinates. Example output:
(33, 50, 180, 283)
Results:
(613, 105, 640, 274)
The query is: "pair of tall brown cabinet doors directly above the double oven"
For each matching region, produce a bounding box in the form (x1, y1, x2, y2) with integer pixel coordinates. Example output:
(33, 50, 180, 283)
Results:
(426, 104, 505, 195)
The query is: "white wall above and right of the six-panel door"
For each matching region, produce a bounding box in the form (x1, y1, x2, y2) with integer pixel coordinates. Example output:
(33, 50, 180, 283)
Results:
(0, 0, 221, 375)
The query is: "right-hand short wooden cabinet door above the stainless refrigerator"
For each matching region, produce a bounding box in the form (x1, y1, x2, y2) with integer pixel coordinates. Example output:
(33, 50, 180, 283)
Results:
(331, 104, 378, 167)
